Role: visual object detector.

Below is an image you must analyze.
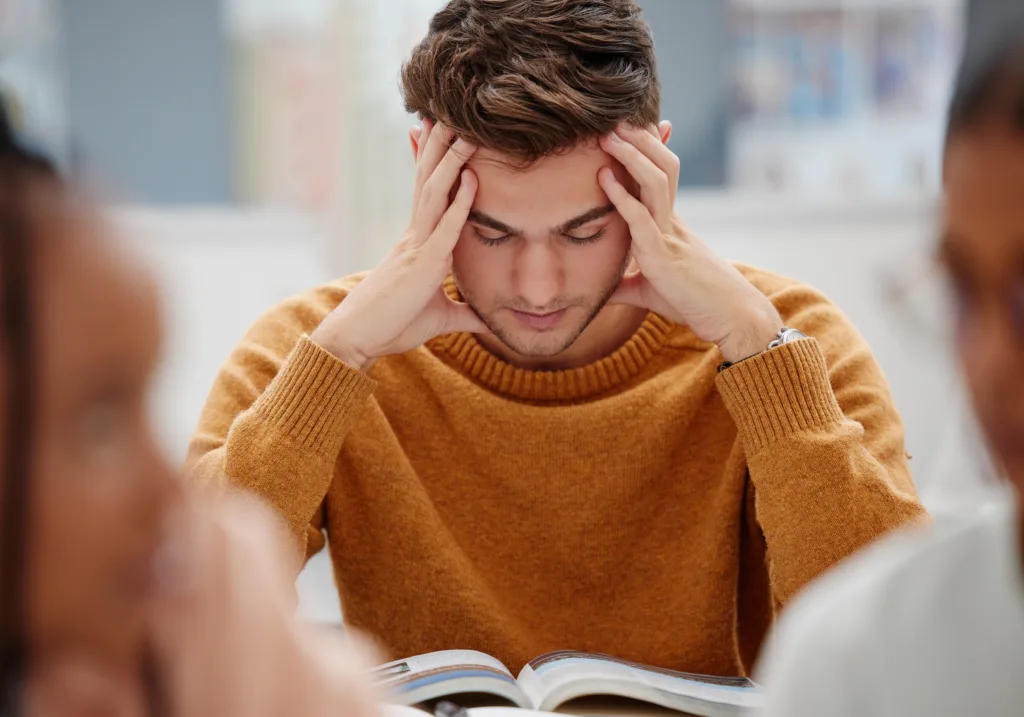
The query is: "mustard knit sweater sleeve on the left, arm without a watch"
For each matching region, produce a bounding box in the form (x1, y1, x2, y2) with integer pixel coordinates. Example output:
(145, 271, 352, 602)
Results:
(186, 282, 375, 558)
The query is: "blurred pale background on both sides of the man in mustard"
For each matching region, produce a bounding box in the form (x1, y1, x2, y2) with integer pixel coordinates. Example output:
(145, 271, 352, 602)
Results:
(0, 0, 1022, 618)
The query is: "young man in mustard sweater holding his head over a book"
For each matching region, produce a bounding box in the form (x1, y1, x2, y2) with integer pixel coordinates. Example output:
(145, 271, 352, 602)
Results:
(190, 0, 924, 674)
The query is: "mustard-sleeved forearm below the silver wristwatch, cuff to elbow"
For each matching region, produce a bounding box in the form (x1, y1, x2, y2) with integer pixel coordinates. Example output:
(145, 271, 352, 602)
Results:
(719, 341, 926, 601)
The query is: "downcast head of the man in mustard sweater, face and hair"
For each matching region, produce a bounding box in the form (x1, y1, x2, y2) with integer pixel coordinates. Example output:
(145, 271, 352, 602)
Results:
(402, 0, 669, 357)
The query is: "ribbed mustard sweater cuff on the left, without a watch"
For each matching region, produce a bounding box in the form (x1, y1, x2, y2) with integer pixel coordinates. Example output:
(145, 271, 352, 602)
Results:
(252, 336, 377, 453)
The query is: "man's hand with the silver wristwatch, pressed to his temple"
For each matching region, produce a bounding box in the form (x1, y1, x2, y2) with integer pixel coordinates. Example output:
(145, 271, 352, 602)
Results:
(598, 123, 782, 363)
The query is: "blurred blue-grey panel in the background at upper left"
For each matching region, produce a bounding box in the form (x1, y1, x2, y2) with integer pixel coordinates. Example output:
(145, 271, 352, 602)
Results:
(58, 0, 234, 204)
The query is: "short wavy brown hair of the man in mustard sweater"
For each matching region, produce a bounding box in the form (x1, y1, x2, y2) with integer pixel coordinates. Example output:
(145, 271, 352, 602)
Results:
(401, 0, 660, 166)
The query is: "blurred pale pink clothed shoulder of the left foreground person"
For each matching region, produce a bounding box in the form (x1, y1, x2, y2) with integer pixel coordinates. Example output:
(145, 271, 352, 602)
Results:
(151, 492, 376, 717)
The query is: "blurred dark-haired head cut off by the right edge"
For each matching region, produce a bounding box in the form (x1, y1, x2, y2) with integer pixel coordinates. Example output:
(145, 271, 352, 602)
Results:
(940, 20, 1024, 493)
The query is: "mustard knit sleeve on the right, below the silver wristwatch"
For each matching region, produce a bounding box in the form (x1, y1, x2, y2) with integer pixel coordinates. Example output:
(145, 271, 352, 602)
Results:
(717, 276, 927, 603)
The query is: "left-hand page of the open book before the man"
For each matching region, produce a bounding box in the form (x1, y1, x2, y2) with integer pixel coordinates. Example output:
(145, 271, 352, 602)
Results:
(371, 649, 529, 707)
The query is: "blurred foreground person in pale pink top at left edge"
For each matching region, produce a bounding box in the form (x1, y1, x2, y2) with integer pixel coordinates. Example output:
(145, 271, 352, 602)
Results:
(0, 109, 375, 717)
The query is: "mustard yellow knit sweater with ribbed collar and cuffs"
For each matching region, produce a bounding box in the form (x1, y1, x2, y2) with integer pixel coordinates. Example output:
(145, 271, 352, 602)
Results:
(189, 267, 924, 674)
